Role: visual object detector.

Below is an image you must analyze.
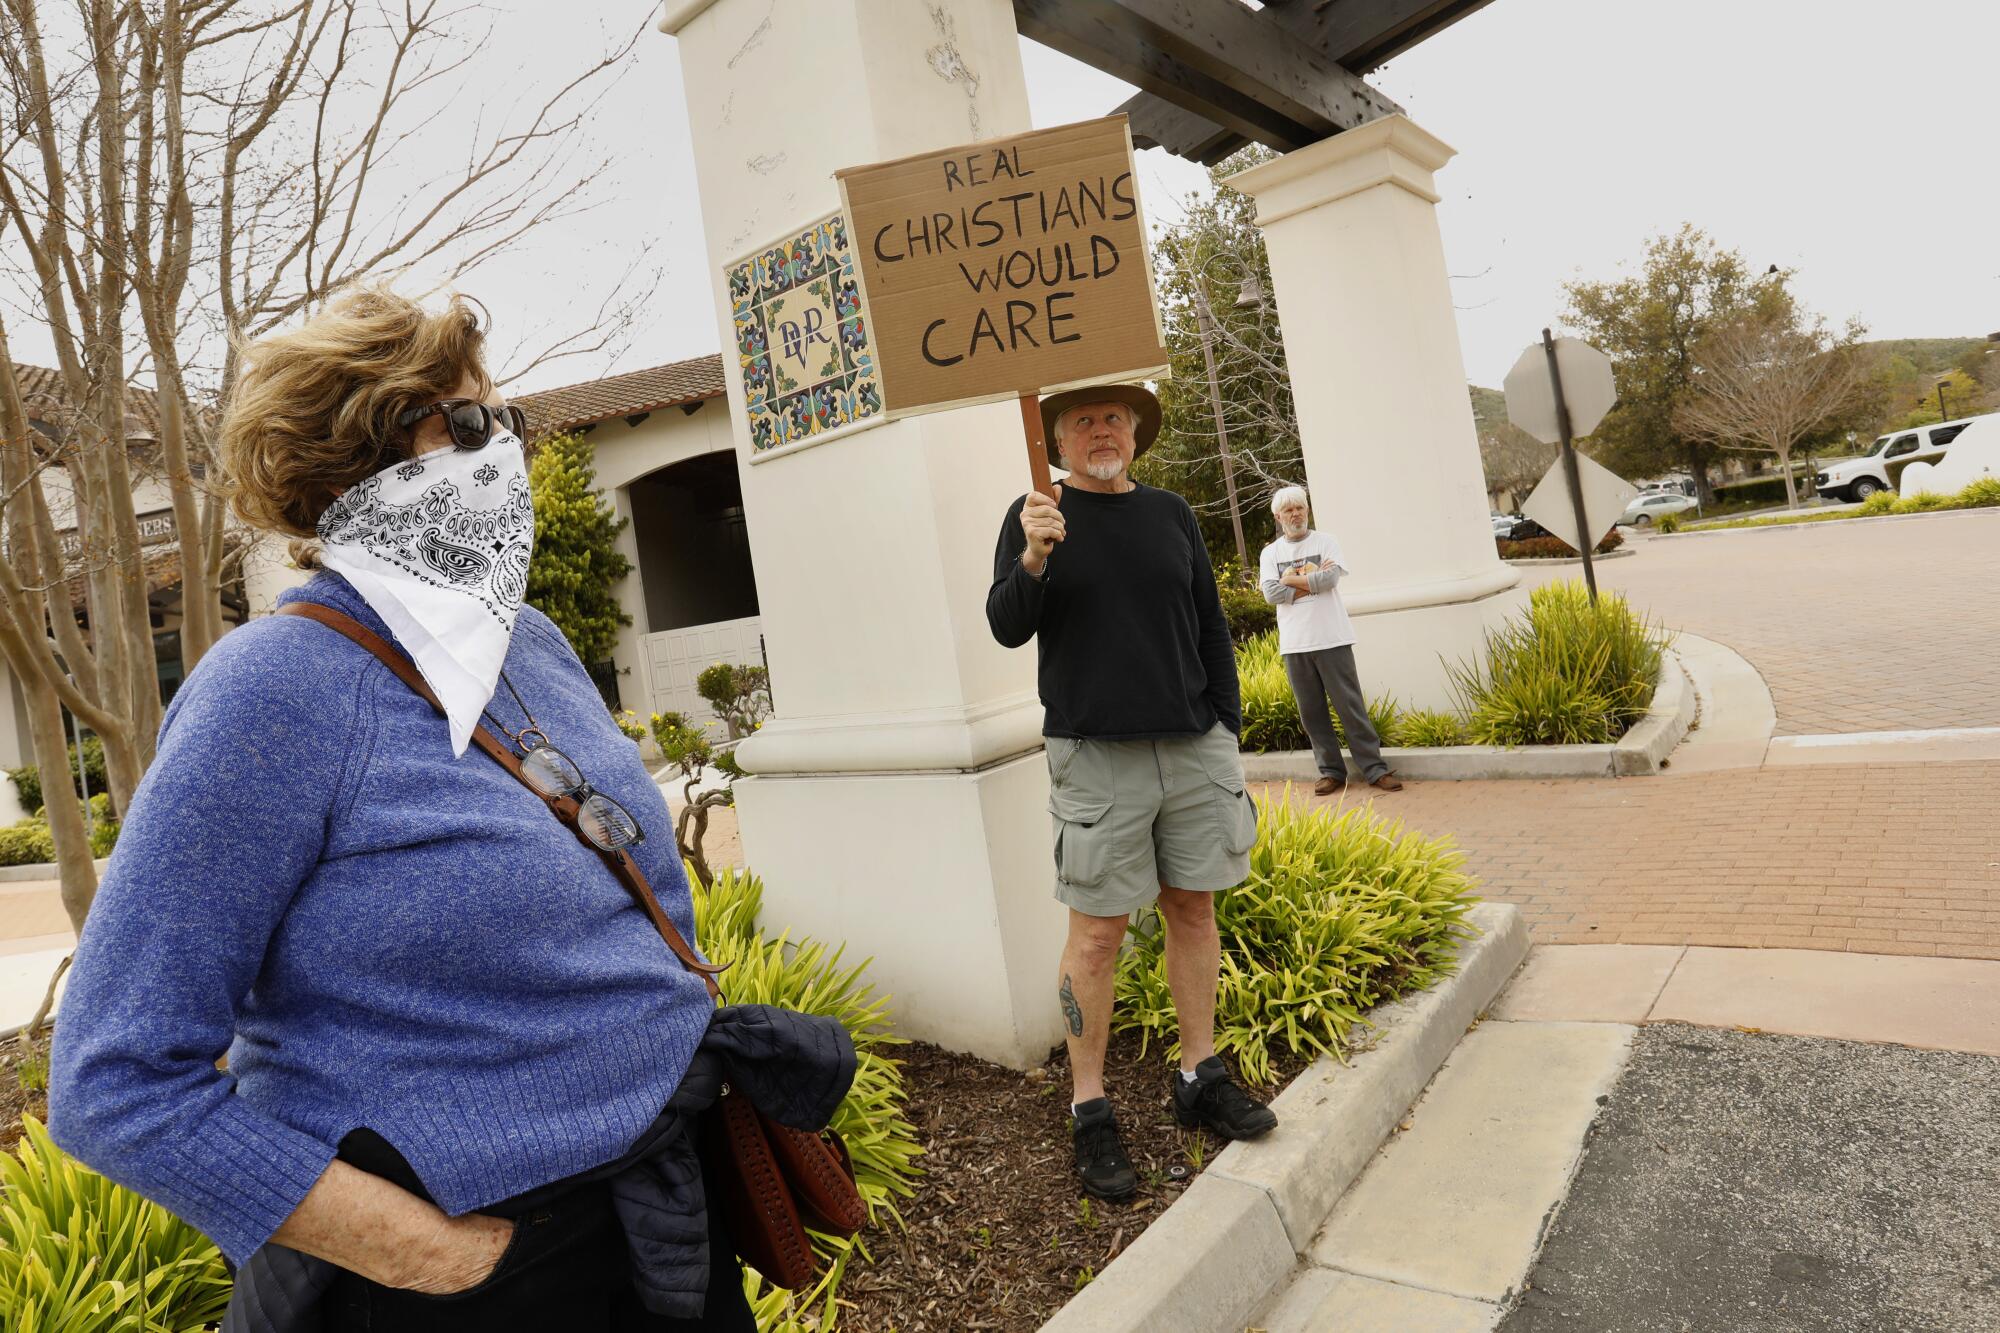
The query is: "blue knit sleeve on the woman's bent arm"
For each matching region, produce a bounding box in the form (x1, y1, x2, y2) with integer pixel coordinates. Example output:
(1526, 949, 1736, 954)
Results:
(48, 616, 366, 1263)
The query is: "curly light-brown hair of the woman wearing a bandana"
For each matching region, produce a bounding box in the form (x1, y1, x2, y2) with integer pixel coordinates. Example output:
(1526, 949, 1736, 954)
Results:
(222, 286, 492, 544)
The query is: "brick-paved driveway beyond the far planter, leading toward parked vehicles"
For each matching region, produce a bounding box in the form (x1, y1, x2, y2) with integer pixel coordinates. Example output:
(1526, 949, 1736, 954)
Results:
(1512, 510, 2000, 737)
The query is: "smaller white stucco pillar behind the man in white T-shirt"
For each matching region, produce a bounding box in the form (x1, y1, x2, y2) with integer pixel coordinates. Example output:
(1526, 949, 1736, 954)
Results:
(1228, 116, 1524, 709)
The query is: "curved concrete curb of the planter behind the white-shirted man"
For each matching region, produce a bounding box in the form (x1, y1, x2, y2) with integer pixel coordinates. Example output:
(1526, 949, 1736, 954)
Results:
(1242, 652, 1694, 783)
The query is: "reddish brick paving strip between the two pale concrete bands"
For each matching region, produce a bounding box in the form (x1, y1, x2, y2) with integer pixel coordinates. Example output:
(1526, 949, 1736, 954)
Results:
(1270, 763, 2000, 959)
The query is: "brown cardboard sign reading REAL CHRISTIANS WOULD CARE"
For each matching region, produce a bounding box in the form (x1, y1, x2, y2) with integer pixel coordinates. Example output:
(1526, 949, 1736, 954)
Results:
(838, 116, 1168, 412)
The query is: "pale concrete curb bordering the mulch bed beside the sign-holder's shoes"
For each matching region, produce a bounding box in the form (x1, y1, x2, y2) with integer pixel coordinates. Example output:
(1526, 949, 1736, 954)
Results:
(1042, 903, 1528, 1333)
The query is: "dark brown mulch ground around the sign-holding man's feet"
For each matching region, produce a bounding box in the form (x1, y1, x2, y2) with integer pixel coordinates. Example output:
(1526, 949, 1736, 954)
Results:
(840, 1033, 1304, 1333)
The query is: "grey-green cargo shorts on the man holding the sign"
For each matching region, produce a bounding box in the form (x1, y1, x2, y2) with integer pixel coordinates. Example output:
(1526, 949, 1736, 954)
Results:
(1046, 723, 1256, 917)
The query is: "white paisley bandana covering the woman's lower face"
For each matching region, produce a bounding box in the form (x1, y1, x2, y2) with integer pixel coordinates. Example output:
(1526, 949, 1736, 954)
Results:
(320, 430, 534, 755)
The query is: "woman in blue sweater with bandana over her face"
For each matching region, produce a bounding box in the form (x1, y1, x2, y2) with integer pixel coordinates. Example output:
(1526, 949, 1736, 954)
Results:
(50, 290, 852, 1333)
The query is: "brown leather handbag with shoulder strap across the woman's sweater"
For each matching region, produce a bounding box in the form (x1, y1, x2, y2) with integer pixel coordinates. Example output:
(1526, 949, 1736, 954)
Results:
(278, 602, 868, 1291)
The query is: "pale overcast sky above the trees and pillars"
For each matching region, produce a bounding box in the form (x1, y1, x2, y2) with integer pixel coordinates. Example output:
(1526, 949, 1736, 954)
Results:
(10, 0, 2000, 388)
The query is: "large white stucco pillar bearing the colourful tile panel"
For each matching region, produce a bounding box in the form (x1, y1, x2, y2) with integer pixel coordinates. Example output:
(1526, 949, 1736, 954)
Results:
(662, 0, 1064, 1065)
